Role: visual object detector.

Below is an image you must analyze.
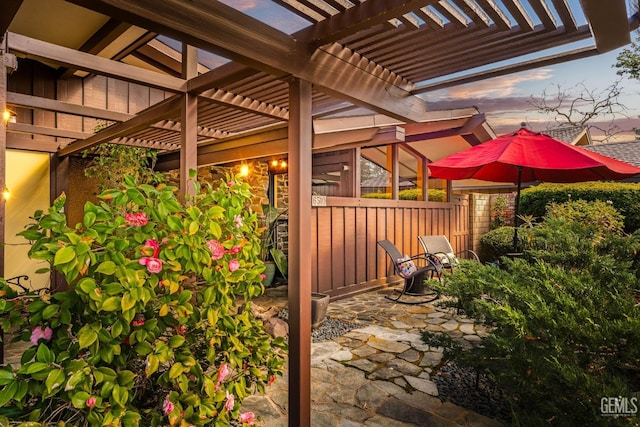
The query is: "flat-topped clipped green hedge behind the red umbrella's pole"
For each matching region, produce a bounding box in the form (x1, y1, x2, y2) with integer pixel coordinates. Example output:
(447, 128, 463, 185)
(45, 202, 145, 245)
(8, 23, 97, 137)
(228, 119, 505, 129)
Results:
(520, 182, 640, 232)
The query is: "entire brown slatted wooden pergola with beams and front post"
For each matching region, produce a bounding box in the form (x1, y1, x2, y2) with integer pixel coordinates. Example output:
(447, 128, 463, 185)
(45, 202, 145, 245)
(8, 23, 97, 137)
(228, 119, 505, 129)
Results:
(0, 0, 638, 426)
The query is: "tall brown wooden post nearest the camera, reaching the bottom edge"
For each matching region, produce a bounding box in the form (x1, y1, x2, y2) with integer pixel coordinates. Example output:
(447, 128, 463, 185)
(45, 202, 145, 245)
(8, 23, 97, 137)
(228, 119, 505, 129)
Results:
(288, 79, 313, 427)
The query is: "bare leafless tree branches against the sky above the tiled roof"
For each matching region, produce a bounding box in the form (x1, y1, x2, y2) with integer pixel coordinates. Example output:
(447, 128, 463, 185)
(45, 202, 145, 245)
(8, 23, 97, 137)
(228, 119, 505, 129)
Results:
(529, 80, 629, 142)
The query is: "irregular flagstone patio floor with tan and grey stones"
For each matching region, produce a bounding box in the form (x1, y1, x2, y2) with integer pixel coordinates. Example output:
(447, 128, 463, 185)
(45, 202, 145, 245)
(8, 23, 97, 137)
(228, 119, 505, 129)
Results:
(243, 289, 502, 427)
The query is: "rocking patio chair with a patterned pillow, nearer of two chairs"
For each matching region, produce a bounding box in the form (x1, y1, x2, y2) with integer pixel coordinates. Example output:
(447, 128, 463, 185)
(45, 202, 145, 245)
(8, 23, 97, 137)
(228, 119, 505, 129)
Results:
(378, 240, 441, 304)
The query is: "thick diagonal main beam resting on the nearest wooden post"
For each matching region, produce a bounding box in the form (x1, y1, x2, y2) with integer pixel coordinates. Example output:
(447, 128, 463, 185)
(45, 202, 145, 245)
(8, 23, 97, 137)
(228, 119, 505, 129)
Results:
(67, 0, 424, 121)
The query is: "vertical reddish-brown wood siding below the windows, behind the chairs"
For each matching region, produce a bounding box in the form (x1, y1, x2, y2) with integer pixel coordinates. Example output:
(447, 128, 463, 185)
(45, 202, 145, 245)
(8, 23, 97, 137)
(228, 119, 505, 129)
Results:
(311, 195, 470, 298)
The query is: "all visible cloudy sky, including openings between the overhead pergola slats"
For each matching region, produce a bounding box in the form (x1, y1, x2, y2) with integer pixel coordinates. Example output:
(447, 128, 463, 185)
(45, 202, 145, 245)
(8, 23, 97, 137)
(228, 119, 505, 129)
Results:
(222, 0, 640, 142)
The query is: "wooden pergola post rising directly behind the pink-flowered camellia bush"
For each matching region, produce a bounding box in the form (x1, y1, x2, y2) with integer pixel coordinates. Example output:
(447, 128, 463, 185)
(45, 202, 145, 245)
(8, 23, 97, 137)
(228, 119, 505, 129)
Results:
(180, 44, 198, 196)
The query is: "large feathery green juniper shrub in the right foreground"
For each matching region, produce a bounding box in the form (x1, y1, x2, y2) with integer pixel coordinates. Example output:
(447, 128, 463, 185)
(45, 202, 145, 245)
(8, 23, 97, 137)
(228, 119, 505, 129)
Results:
(424, 202, 640, 426)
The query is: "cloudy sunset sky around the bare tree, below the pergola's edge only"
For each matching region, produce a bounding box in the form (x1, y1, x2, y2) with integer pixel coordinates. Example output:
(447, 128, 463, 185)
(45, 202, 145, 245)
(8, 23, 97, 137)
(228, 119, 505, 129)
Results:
(424, 45, 640, 142)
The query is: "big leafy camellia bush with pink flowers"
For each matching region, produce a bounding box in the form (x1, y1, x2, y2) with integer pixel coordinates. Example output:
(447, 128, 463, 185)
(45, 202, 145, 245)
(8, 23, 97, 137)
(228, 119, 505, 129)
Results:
(0, 174, 286, 426)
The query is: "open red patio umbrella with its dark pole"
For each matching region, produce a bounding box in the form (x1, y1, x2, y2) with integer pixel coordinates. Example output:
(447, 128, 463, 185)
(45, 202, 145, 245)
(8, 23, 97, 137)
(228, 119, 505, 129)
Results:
(429, 128, 640, 252)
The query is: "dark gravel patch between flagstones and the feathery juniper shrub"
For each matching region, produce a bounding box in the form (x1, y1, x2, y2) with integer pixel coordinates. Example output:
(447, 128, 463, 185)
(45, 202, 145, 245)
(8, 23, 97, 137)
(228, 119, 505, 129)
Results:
(431, 361, 511, 423)
